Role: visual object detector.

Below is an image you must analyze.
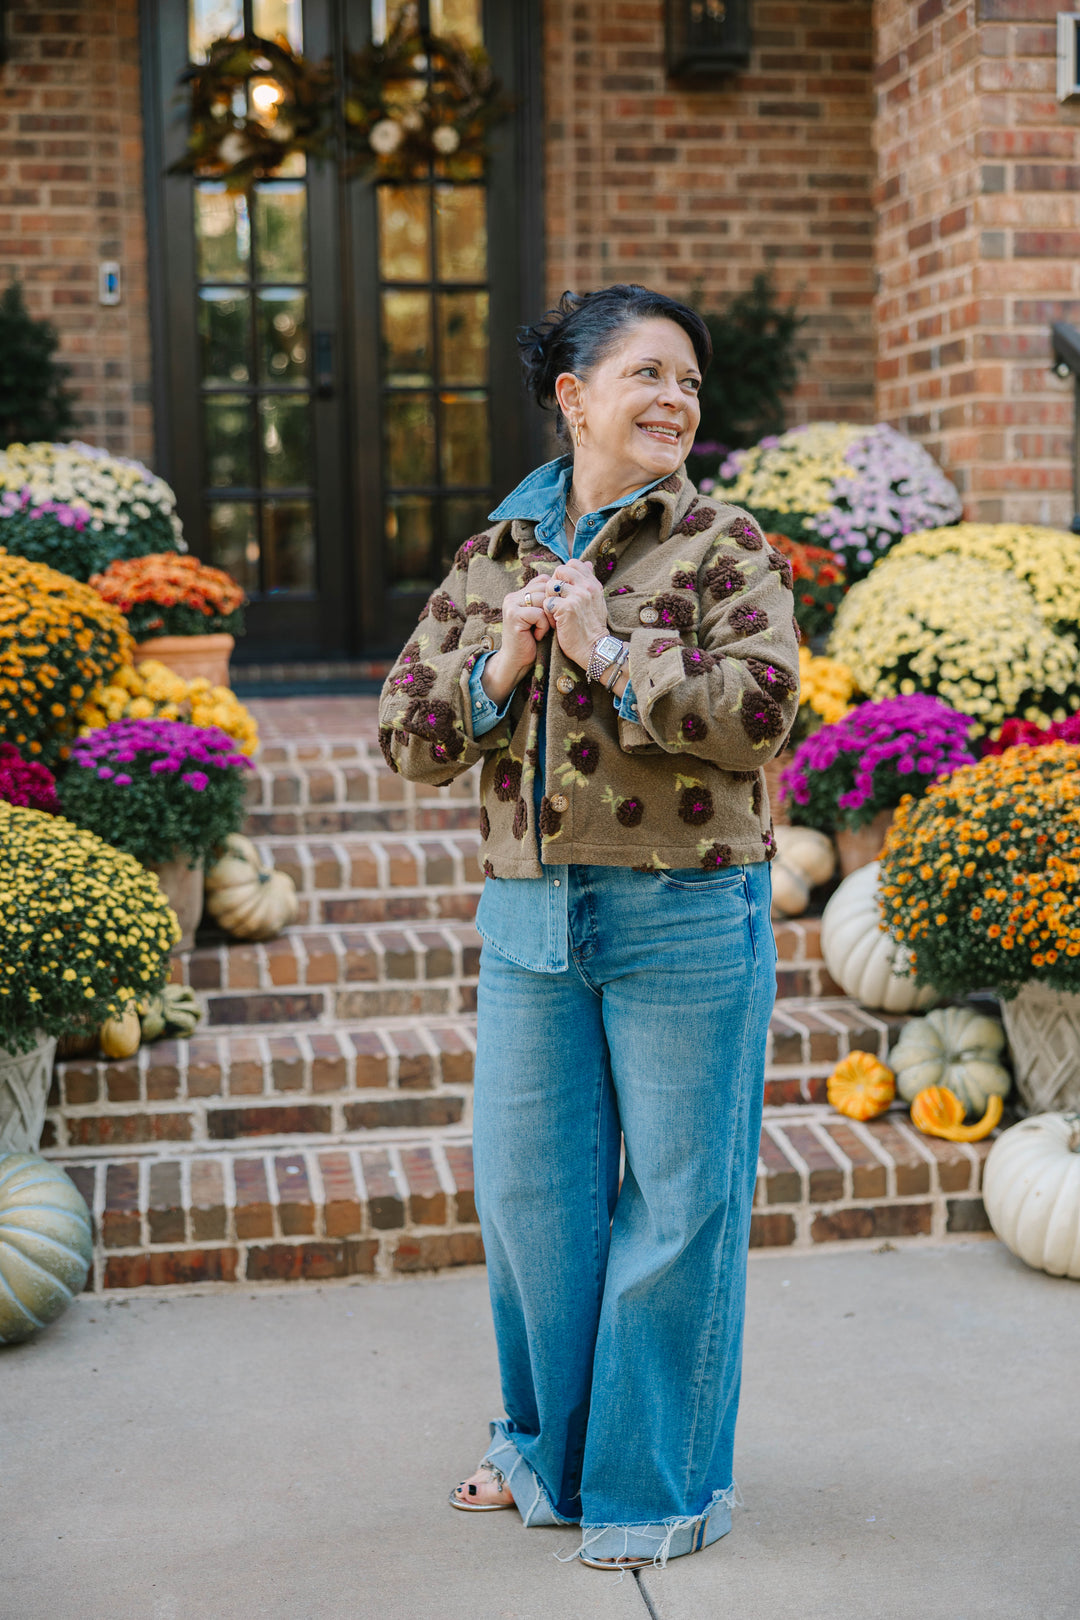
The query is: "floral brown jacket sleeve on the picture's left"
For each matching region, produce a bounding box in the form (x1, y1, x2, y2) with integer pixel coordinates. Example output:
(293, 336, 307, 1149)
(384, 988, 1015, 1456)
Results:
(379, 536, 513, 786)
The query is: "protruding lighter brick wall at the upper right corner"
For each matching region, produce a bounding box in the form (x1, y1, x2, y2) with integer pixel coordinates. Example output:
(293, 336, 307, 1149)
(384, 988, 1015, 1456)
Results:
(876, 0, 1080, 523)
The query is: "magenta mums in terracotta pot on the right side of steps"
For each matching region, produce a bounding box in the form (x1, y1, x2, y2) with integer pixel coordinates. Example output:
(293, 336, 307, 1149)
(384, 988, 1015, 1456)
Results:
(780, 693, 975, 876)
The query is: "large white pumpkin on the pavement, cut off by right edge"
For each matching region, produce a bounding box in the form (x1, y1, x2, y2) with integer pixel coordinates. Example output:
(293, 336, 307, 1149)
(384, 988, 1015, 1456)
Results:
(983, 1113, 1080, 1280)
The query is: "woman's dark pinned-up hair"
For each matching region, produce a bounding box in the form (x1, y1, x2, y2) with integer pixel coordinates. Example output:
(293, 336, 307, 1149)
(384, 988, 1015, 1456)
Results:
(518, 282, 712, 439)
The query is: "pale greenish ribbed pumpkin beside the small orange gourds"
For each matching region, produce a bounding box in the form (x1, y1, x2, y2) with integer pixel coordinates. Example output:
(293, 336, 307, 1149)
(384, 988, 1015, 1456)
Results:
(889, 1008, 1012, 1119)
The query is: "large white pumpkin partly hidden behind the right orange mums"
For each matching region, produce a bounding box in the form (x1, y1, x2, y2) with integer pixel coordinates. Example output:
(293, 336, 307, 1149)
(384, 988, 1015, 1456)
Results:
(821, 860, 938, 1013)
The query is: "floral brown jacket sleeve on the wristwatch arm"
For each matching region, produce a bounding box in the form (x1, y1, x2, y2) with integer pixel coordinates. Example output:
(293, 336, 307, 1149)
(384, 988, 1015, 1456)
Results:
(619, 507, 798, 771)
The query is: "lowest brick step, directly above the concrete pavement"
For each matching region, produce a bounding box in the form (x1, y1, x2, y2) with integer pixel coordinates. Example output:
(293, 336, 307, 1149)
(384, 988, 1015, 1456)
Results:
(49, 1110, 989, 1291)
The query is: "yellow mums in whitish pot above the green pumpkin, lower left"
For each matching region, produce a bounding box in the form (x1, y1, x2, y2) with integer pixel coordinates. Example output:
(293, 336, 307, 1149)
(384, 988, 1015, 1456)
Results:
(0, 802, 176, 1152)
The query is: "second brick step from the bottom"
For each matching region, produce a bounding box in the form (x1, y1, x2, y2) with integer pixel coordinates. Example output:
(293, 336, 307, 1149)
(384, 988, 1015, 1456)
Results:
(42, 998, 904, 1150)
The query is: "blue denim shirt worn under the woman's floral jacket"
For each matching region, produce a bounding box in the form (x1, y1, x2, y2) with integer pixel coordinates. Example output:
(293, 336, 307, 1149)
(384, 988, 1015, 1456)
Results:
(470, 455, 661, 974)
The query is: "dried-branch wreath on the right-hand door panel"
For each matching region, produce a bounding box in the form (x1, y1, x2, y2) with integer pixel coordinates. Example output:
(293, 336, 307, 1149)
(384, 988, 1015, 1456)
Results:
(343, 6, 513, 180)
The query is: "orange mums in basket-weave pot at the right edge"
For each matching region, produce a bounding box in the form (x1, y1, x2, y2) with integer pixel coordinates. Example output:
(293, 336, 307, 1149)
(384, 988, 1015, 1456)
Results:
(881, 742, 1080, 1113)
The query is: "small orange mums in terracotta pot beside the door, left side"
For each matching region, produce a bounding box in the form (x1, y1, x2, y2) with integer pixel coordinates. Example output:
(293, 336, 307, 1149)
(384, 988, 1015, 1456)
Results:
(91, 551, 244, 687)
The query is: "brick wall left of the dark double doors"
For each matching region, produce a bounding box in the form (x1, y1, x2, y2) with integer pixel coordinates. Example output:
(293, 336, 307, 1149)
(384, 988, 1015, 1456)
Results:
(0, 0, 152, 458)
